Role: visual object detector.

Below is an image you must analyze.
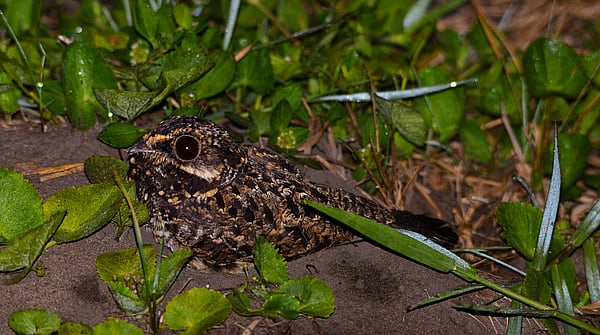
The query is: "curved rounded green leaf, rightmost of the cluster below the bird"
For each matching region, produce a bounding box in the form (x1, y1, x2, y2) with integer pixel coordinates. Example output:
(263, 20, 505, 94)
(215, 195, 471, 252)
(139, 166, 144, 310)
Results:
(275, 276, 335, 318)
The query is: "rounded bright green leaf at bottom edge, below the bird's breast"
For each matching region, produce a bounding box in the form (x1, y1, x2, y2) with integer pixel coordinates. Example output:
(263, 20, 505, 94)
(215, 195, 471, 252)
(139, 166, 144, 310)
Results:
(164, 288, 231, 335)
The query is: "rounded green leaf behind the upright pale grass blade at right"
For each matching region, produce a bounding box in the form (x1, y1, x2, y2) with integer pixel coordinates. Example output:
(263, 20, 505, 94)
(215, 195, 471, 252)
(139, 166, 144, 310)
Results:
(544, 134, 592, 190)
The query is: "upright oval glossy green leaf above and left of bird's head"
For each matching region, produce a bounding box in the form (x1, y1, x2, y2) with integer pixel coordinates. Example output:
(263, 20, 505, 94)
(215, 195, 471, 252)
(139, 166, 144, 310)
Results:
(63, 41, 117, 130)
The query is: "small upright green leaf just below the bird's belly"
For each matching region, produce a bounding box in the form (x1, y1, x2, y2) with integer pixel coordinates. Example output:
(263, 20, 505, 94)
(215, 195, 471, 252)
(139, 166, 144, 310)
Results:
(254, 236, 290, 285)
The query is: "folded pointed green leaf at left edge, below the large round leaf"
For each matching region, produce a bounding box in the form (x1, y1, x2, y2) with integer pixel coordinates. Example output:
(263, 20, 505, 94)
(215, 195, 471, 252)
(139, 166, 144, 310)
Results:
(0, 211, 65, 284)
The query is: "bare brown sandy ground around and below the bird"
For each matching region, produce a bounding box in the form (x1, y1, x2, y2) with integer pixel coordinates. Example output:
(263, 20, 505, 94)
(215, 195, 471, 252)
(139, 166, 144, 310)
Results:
(0, 121, 537, 335)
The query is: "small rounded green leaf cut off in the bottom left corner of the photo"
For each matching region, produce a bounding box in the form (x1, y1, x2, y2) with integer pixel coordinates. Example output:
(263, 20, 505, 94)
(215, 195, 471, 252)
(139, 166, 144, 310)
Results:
(8, 309, 62, 335)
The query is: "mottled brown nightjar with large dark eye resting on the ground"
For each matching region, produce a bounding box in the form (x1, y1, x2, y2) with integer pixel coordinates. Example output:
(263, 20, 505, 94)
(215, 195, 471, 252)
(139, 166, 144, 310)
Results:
(128, 116, 457, 271)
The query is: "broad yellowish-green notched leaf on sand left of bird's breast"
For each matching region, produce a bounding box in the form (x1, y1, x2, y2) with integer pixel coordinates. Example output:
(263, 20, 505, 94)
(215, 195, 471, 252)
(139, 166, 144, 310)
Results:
(43, 183, 123, 243)
